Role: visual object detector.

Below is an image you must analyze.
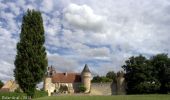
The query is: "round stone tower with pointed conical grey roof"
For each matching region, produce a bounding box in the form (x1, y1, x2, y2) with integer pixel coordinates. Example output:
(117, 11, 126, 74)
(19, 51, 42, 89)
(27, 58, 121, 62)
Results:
(81, 64, 91, 93)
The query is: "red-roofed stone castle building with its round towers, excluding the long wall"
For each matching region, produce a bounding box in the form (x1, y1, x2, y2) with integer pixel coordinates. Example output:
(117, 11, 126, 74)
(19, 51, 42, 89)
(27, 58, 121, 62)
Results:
(44, 64, 91, 96)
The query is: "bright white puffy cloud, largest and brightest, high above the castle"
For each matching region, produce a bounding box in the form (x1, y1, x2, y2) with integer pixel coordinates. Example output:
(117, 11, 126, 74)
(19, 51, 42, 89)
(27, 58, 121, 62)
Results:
(64, 3, 106, 31)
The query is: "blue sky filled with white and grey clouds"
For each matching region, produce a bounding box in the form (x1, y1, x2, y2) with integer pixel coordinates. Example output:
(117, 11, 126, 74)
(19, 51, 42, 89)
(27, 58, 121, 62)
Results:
(0, 0, 170, 82)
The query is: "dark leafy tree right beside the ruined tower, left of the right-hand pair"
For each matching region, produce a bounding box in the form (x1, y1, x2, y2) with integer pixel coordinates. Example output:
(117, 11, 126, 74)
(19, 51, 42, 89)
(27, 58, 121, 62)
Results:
(122, 55, 160, 94)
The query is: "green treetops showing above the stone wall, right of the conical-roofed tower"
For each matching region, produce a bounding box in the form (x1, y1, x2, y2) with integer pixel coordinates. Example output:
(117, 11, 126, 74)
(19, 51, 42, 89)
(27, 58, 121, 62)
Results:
(92, 76, 112, 83)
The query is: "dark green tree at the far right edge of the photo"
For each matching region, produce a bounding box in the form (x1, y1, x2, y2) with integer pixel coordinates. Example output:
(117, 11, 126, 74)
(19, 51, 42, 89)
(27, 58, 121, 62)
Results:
(150, 54, 170, 93)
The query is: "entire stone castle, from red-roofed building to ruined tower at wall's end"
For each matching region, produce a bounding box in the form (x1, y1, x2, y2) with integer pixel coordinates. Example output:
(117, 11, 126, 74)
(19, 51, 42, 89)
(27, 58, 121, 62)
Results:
(44, 64, 126, 96)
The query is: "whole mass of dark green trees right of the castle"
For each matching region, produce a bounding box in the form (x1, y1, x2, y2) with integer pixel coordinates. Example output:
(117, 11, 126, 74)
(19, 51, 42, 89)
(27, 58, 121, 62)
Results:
(122, 54, 170, 94)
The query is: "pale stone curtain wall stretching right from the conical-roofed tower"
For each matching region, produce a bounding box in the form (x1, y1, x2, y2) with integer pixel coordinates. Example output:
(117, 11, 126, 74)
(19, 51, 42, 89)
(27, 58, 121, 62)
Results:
(90, 83, 116, 95)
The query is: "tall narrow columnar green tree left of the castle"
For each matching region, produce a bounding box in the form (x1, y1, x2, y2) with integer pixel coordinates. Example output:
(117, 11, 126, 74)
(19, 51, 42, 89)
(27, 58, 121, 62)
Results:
(14, 10, 47, 97)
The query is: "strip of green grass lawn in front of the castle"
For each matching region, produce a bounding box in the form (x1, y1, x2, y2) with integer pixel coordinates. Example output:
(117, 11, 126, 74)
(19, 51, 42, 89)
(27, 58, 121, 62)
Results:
(34, 94, 170, 100)
